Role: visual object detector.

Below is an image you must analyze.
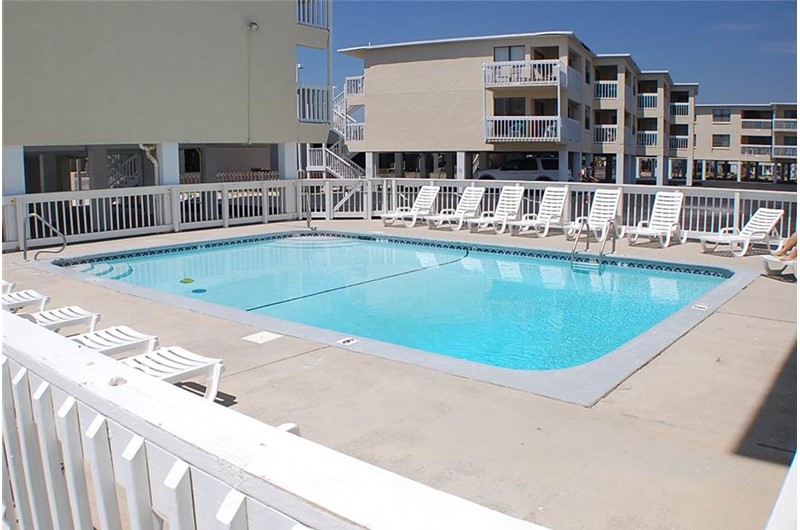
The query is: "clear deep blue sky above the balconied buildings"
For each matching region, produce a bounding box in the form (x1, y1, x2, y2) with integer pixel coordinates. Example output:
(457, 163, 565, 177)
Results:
(301, 0, 797, 103)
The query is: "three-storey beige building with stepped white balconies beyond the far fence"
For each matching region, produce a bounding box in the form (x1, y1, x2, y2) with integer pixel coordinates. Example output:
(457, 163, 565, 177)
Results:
(334, 31, 796, 184)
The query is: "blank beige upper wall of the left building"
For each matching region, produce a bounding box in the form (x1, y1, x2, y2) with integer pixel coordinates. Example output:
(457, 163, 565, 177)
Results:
(3, 1, 328, 145)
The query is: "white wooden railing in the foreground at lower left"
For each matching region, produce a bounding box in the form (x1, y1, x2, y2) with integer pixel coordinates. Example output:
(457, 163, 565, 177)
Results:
(0, 311, 543, 530)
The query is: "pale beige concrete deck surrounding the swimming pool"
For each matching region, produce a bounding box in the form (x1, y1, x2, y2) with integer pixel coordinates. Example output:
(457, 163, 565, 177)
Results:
(3, 220, 797, 530)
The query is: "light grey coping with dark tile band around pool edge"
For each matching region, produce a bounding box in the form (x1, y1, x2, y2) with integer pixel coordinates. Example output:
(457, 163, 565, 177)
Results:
(37, 229, 760, 407)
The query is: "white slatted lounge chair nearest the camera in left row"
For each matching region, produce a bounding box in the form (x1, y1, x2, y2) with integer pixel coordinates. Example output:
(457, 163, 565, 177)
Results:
(120, 346, 225, 401)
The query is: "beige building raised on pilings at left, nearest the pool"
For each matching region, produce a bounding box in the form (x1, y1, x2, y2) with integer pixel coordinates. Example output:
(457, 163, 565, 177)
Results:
(3, 0, 332, 195)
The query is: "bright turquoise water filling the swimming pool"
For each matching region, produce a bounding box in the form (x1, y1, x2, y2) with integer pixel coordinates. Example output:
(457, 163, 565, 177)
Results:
(67, 233, 725, 370)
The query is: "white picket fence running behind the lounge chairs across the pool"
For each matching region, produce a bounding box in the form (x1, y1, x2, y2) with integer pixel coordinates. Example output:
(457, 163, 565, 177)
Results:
(3, 178, 798, 250)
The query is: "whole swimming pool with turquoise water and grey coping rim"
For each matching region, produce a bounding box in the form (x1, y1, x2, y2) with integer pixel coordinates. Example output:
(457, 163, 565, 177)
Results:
(55, 231, 750, 404)
